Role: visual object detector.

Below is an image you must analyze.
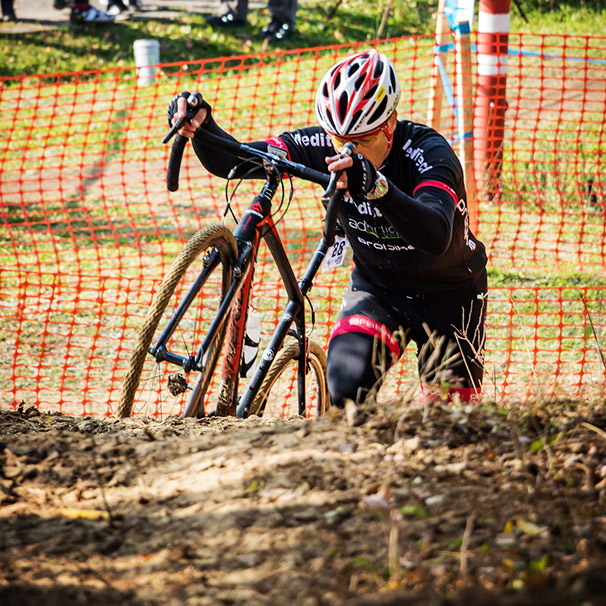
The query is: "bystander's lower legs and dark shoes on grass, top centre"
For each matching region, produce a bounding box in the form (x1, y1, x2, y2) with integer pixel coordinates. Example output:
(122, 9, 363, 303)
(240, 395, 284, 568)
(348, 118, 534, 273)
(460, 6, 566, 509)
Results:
(206, 0, 297, 41)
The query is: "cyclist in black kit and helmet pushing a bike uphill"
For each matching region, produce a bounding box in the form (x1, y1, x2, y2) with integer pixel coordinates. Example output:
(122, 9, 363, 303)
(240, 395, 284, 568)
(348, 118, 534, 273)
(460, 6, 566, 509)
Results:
(168, 49, 487, 406)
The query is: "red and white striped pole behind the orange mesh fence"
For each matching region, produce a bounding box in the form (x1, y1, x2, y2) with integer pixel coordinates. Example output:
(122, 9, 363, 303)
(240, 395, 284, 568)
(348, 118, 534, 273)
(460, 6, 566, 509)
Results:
(473, 0, 511, 198)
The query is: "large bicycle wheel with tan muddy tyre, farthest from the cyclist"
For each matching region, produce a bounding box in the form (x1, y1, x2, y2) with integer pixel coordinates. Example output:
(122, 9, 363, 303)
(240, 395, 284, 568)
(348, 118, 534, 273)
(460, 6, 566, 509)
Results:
(118, 225, 237, 417)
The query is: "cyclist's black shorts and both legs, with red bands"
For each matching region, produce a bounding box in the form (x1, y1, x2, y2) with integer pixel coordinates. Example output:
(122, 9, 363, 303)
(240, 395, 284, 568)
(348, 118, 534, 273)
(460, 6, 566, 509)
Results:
(328, 268, 487, 406)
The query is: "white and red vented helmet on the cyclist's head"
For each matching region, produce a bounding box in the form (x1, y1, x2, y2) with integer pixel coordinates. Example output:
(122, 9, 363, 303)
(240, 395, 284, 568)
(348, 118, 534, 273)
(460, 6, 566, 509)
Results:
(316, 49, 400, 137)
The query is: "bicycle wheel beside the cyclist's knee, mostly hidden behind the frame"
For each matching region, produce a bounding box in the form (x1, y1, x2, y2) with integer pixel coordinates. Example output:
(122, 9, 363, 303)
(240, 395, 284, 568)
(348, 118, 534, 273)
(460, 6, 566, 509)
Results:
(249, 341, 330, 417)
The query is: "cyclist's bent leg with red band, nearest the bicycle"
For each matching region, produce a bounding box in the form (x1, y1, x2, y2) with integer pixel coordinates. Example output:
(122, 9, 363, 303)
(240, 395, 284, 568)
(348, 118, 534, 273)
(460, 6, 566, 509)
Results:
(328, 270, 402, 407)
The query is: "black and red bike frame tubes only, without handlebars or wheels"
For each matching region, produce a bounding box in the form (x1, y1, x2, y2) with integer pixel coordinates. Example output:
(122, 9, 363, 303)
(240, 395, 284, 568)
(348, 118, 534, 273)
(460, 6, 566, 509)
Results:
(150, 159, 329, 417)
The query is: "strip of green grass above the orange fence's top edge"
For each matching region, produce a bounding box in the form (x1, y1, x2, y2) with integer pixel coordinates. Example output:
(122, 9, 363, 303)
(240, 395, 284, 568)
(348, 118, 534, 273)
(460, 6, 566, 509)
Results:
(0, 0, 606, 76)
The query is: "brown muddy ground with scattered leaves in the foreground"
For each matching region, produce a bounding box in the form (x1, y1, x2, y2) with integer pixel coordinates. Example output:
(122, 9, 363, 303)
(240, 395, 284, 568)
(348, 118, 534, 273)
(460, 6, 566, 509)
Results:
(0, 402, 606, 606)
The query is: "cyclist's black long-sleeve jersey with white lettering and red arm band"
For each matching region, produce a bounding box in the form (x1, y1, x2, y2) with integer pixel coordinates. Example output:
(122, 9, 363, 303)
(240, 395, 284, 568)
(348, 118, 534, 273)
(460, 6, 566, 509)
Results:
(194, 117, 486, 296)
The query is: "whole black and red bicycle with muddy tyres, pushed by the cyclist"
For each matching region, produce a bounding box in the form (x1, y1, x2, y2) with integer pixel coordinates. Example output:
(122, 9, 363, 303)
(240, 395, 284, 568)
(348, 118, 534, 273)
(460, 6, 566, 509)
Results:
(118, 95, 354, 417)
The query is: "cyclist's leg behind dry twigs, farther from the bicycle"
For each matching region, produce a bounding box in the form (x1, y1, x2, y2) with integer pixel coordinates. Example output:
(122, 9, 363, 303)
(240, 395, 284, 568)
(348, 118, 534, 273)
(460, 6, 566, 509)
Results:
(412, 276, 486, 402)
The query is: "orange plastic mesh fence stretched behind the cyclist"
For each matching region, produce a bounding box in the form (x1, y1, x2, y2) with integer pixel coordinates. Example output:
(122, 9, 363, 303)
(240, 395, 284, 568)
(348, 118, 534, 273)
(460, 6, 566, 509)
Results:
(0, 35, 606, 414)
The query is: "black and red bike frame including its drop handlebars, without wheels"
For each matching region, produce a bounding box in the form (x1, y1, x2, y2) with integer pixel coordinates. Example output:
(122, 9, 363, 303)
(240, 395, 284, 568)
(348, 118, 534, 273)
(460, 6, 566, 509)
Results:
(154, 121, 355, 417)
